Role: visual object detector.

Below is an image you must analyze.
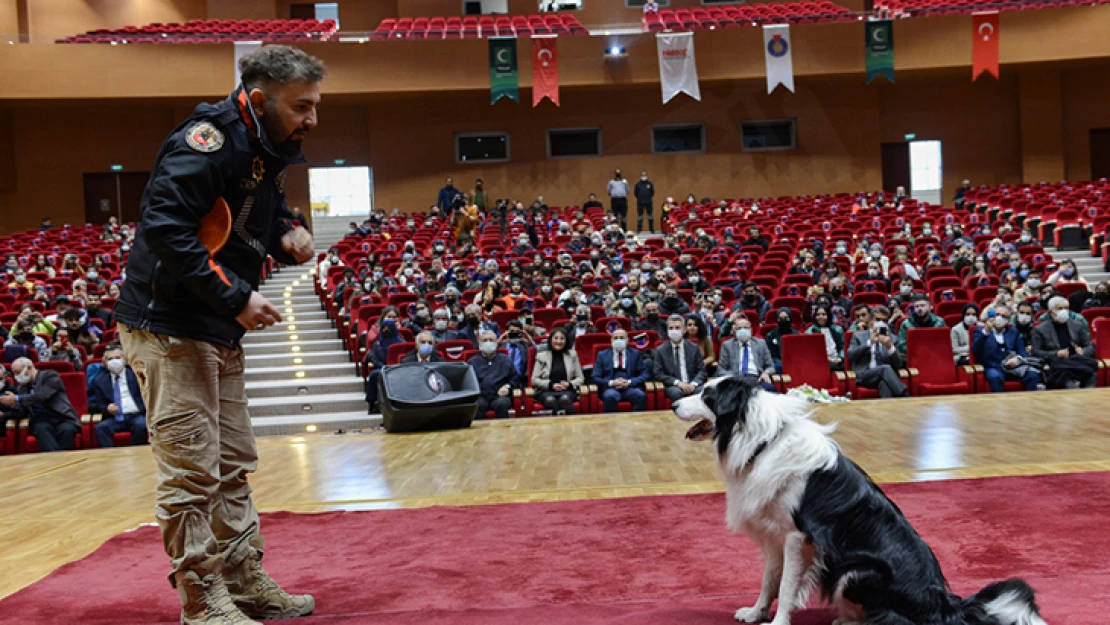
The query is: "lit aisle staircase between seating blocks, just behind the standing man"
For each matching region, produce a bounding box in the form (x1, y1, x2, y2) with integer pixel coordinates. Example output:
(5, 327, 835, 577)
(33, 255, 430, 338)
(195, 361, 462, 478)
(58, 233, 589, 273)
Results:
(243, 216, 381, 435)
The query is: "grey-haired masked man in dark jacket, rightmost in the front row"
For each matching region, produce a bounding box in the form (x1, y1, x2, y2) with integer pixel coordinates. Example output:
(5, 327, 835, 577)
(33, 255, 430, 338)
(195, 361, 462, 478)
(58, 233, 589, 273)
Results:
(1033, 295, 1098, 389)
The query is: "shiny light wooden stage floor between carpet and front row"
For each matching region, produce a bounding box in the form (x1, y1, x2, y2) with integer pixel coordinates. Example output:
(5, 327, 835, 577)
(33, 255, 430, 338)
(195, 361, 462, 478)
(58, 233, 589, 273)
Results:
(0, 389, 1110, 597)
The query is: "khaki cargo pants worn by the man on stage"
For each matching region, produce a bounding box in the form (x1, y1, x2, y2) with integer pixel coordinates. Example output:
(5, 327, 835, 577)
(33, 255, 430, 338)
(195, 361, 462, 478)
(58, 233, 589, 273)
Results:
(120, 324, 259, 584)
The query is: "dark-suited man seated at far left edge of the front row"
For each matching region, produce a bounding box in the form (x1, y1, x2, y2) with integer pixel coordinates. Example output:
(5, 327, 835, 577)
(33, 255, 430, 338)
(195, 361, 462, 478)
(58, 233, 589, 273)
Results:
(0, 359, 81, 452)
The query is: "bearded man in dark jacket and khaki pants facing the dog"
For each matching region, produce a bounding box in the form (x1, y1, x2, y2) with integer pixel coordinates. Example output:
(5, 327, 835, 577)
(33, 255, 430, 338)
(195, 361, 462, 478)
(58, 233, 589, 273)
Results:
(115, 46, 324, 625)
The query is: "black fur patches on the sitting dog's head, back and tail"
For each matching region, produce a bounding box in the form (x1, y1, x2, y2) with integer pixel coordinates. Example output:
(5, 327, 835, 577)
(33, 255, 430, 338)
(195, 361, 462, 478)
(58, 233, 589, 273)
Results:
(703, 379, 1042, 625)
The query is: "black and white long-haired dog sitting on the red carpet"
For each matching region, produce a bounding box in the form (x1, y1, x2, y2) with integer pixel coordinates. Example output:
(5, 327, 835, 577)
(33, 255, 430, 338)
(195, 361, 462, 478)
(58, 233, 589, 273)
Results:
(674, 377, 1045, 625)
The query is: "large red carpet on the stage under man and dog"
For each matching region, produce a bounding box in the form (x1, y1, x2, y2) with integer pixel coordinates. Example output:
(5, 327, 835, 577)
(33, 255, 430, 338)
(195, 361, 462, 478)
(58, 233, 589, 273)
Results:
(0, 473, 1110, 625)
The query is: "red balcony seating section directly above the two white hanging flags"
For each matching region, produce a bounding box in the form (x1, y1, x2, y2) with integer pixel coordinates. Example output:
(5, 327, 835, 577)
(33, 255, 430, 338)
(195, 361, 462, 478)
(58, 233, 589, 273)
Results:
(644, 0, 861, 32)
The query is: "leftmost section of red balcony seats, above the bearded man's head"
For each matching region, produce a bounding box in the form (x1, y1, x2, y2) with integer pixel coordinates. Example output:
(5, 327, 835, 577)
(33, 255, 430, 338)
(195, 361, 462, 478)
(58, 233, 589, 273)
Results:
(56, 19, 337, 43)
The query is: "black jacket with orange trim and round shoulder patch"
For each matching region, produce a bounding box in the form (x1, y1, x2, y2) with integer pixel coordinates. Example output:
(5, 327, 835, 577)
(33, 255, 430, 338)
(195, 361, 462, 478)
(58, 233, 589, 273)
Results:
(115, 87, 305, 347)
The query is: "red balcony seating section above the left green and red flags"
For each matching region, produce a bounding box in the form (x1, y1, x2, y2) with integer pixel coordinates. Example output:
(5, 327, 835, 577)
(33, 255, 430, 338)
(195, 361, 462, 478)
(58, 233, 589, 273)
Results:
(370, 13, 589, 41)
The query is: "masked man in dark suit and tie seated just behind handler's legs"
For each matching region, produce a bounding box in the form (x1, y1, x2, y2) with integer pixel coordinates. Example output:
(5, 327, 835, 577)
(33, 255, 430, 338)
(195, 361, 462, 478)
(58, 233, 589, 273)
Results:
(92, 343, 147, 447)
